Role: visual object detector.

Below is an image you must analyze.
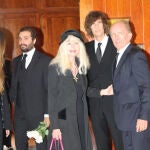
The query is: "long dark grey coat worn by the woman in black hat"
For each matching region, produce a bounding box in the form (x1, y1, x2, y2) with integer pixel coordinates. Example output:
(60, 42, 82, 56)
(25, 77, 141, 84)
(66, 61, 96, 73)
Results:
(48, 65, 92, 150)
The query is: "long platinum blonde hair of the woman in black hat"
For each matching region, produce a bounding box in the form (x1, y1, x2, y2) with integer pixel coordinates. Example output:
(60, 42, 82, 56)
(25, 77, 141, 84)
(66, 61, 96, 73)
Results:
(50, 35, 90, 75)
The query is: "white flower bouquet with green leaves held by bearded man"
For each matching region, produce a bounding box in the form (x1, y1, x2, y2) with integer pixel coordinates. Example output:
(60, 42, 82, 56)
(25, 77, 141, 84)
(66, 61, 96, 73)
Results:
(27, 122, 48, 143)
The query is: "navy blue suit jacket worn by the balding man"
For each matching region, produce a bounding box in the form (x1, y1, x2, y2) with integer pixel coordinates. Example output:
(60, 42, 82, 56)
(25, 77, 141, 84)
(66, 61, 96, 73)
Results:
(113, 44, 150, 130)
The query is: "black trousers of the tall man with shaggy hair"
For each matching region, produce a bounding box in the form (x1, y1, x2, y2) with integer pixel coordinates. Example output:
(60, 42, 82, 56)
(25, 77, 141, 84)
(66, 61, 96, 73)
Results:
(89, 96, 123, 150)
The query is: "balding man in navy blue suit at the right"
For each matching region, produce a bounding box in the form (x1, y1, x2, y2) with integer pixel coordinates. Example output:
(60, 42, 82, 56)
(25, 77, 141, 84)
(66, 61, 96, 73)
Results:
(110, 21, 150, 150)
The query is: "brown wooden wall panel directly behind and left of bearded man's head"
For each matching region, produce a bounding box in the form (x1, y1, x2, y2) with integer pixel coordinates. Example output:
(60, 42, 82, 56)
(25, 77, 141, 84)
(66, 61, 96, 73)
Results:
(0, 14, 39, 59)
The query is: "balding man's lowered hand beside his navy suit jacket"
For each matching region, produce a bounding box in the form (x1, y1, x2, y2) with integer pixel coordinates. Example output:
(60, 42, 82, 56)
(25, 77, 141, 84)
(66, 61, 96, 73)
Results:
(136, 119, 148, 132)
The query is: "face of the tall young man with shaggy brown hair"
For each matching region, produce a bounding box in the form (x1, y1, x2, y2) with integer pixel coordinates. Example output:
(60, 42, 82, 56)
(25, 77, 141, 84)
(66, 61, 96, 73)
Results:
(91, 19, 105, 38)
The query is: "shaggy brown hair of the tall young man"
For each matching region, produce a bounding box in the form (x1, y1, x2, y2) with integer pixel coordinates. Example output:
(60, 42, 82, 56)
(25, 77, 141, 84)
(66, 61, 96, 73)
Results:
(84, 11, 109, 37)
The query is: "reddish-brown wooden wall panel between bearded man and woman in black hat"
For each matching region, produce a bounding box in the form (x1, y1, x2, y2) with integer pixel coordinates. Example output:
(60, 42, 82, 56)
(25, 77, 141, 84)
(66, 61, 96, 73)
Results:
(42, 14, 79, 56)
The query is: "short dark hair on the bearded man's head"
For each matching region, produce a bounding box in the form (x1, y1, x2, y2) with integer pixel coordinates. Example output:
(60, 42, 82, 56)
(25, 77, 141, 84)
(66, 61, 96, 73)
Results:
(19, 26, 37, 40)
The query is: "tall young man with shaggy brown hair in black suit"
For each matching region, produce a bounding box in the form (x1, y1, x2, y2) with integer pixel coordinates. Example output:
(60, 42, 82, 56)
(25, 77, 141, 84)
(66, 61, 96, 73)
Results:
(85, 11, 123, 150)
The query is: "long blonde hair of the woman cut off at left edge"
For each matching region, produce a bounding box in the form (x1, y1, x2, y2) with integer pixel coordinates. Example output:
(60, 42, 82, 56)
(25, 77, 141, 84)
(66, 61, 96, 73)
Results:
(0, 31, 6, 94)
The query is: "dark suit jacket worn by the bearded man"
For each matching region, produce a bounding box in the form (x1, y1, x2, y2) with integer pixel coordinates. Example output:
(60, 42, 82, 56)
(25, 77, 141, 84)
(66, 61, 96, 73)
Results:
(10, 50, 50, 129)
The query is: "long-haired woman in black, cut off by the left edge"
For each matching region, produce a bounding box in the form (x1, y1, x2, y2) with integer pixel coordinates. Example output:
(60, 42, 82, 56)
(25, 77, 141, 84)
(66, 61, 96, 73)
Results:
(0, 31, 11, 150)
